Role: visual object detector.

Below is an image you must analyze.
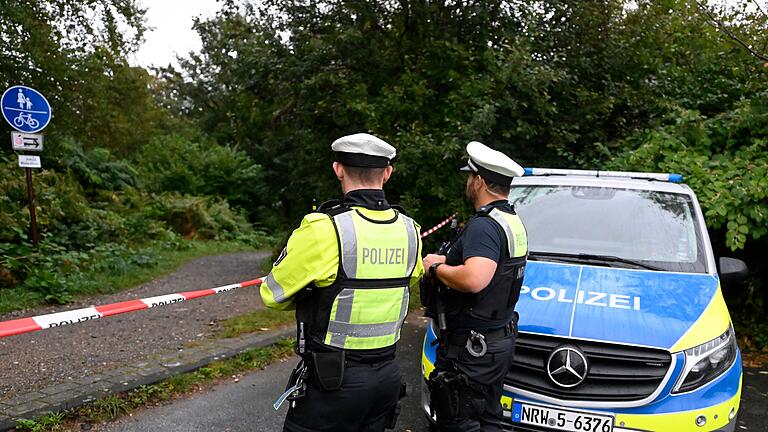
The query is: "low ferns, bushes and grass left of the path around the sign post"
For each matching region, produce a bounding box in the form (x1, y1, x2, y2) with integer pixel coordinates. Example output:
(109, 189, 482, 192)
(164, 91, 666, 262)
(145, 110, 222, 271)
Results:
(0, 137, 274, 312)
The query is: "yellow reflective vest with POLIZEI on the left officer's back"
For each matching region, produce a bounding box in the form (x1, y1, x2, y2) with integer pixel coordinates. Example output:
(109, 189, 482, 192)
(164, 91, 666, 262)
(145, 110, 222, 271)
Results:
(311, 209, 421, 350)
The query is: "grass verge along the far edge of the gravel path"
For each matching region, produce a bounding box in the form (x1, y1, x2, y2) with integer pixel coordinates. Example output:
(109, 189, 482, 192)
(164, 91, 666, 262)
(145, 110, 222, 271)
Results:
(0, 240, 253, 313)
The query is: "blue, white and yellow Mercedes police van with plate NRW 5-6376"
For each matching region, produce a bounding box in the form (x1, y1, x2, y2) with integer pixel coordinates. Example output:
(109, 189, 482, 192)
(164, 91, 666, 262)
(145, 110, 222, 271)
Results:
(422, 169, 746, 432)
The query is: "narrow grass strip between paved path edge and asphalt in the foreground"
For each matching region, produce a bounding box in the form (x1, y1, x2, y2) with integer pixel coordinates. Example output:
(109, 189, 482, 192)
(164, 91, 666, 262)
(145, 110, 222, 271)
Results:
(16, 339, 295, 432)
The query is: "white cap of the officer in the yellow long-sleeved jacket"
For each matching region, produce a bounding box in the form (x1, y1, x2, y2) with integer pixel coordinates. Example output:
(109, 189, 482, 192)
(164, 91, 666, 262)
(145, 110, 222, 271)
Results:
(331, 133, 397, 168)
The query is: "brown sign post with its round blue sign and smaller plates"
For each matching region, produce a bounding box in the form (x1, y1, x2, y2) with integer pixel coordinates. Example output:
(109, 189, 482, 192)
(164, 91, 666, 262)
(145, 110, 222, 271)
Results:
(0, 85, 51, 250)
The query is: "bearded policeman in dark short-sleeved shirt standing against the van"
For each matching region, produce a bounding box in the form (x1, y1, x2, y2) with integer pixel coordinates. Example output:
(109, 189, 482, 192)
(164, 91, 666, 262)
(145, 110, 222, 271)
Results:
(424, 141, 528, 432)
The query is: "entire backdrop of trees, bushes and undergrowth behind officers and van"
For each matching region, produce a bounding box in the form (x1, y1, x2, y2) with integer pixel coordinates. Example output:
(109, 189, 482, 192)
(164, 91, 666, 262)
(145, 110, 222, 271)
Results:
(0, 0, 768, 353)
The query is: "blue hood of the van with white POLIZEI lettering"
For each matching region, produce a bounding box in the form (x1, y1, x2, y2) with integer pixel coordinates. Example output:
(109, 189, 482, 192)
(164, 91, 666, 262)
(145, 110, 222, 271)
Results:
(515, 261, 719, 349)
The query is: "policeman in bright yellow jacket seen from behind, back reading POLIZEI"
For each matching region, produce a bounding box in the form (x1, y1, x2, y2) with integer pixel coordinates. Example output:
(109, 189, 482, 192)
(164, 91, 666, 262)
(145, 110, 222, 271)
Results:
(261, 133, 424, 432)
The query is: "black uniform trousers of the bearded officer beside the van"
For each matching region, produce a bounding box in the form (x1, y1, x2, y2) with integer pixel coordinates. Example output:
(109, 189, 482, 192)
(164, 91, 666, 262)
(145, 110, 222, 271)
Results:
(435, 335, 515, 432)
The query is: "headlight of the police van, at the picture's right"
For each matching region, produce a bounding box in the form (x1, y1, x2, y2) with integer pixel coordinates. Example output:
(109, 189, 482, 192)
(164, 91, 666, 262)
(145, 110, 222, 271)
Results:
(672, 327, 738, 393)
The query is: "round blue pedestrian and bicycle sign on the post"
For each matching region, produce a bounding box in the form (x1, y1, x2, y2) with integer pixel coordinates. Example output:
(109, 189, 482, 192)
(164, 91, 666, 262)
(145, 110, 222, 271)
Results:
(0, 86, 51, 133)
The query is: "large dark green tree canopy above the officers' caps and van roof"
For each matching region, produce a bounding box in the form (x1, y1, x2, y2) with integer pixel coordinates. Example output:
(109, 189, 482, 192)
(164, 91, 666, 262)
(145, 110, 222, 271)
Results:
(163, 0, 766, 235)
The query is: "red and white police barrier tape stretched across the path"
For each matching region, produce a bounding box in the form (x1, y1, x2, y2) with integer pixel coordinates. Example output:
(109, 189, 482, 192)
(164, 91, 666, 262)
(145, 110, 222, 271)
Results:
(0, 215, 455, 338)
